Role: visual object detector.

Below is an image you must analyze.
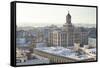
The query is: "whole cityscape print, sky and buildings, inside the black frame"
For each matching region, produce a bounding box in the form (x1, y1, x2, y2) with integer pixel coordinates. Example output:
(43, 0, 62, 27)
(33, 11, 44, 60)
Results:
(16, 4, 97, 65)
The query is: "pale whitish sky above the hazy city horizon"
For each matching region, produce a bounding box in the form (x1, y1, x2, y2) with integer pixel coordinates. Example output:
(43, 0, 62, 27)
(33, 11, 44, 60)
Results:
(16, 3, 96, 26)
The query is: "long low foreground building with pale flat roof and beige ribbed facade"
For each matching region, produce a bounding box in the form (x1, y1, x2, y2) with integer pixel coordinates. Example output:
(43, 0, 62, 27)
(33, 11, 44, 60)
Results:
(34, 47, 95, 63)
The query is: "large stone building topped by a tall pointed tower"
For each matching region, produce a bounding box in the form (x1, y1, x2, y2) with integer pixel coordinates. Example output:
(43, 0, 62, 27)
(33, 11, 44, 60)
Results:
(48, 12, 88, 47)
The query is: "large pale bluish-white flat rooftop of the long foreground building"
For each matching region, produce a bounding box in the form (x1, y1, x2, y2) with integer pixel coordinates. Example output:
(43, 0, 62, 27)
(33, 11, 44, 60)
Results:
(35, 47, 92, 60)
